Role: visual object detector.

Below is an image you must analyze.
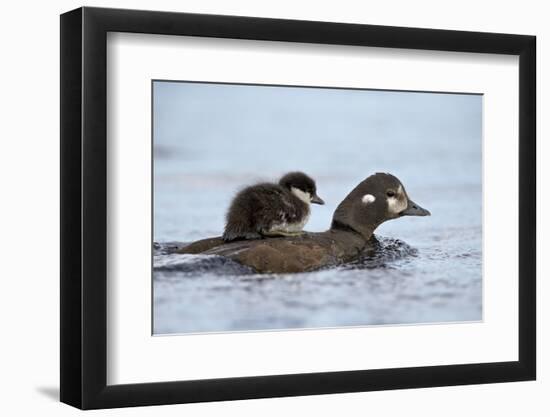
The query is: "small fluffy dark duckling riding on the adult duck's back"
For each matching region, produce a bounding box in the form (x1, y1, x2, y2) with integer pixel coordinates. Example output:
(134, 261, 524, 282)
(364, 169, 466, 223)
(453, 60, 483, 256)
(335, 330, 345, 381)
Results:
(223, 172, 325, 242)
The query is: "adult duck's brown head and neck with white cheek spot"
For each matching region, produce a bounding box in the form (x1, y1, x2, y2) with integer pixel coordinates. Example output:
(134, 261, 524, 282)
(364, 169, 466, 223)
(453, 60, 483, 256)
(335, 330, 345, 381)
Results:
(331, 173, 430, 239)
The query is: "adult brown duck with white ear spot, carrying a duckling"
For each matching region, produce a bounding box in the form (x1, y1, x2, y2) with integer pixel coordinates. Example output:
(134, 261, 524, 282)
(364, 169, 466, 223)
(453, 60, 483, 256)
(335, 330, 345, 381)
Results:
(181, 173, 430, 273)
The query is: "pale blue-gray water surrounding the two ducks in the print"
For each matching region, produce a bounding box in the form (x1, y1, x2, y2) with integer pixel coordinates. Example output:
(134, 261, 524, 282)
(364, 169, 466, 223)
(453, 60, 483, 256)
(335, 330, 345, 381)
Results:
(153, 82, 482, 334)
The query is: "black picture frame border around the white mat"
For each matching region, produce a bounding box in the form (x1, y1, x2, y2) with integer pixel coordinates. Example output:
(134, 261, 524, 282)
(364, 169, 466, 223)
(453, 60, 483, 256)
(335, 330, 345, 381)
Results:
(60, 7, 536, 409)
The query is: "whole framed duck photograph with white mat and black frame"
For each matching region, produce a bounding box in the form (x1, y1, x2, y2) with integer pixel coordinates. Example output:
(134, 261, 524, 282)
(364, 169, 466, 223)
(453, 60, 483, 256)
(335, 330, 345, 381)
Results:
(60, 7, 536, 409)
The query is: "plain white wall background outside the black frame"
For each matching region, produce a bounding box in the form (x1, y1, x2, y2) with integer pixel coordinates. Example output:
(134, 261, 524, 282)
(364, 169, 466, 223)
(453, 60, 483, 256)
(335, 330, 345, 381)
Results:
(0, 0, 550, 417)
